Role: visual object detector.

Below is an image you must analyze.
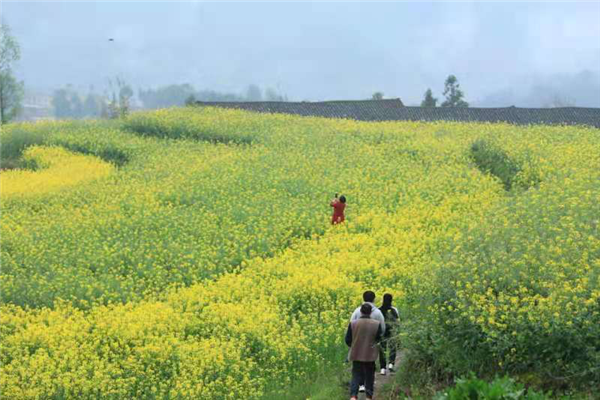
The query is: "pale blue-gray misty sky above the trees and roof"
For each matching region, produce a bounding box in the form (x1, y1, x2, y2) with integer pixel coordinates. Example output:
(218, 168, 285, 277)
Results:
(0, 2, 600, 107)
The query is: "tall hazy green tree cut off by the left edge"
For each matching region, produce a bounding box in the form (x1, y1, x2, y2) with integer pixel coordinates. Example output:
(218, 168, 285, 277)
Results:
(0, 23, 25, 124)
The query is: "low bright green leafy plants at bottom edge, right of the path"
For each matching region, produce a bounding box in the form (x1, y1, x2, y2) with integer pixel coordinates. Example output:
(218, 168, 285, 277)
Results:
(434, 374, 549, 400)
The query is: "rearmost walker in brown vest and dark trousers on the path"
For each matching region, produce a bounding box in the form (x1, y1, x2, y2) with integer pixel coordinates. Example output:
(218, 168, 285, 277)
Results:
(346, 303, 382, 400)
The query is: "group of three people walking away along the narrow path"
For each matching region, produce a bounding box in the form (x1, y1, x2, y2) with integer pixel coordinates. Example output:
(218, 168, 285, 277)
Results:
(346, 290, 399, 400)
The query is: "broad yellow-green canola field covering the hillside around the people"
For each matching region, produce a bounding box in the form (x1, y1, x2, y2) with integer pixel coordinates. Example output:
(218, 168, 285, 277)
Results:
(0, 109, 600, 399)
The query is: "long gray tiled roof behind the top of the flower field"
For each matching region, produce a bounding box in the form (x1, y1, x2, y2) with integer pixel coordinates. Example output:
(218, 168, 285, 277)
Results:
(197, 99, 600, 128)
